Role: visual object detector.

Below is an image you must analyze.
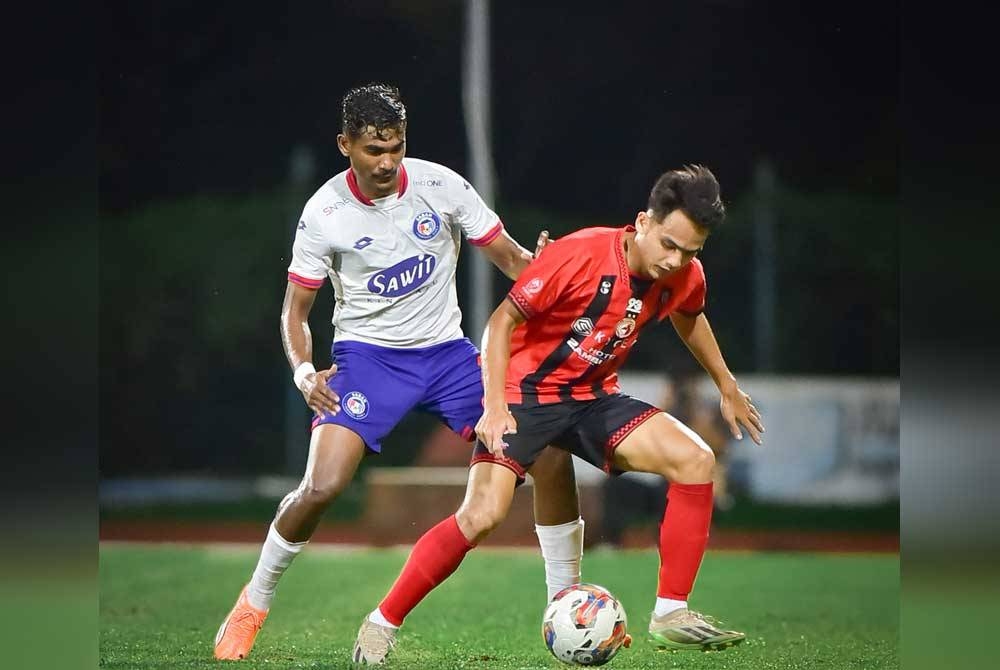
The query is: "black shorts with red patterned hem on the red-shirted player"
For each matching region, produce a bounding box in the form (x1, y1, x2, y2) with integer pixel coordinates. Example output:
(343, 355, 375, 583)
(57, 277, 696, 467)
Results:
(472, 393, 663, 485)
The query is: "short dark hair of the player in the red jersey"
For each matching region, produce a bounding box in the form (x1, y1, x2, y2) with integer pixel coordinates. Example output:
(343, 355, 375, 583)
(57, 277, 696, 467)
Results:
(648, 165, 726, 230)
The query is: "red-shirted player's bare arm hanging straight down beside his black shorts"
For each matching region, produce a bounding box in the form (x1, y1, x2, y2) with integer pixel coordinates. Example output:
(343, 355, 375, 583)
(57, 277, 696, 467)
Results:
(476, 300, 525, 456)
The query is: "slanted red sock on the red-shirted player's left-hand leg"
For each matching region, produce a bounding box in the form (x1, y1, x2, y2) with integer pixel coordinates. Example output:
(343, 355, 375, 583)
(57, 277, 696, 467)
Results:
(378, 514, 475, 626)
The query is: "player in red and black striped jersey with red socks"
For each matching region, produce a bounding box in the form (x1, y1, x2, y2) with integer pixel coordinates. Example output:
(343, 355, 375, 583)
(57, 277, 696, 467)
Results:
(354, 165, 764, 663)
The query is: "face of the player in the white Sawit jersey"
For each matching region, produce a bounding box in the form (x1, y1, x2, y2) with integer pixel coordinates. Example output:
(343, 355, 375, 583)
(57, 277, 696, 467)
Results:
(337, 127, 406, 198)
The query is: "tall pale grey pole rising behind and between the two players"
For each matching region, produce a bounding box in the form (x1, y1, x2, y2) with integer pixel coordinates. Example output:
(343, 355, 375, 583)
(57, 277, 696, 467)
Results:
(462, 0, 495, 346)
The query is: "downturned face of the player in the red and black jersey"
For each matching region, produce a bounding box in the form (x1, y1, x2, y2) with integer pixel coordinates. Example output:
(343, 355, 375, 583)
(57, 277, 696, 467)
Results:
(628, 209, 708, 279)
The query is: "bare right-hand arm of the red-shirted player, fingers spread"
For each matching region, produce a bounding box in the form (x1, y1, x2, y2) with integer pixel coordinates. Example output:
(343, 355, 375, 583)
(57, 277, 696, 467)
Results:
(670, 312, 764, 444)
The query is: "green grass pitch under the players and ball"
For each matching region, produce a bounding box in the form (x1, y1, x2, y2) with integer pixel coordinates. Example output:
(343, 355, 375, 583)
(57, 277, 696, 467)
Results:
(100, 544, 899, 670)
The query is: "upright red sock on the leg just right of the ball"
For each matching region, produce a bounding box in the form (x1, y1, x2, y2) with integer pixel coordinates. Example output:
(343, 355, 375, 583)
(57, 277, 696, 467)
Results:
(656, 482, 712, 600)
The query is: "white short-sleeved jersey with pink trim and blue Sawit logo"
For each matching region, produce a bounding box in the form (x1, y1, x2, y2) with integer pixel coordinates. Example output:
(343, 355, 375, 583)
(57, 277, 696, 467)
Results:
(288, 158, 503, 347)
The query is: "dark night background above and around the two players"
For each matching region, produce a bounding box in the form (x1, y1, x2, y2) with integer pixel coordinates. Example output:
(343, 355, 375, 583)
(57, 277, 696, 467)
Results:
(98, 0, 900, 475)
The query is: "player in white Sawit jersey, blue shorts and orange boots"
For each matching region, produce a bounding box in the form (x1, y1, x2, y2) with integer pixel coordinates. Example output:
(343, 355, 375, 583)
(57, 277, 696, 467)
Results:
(215, 84, 583, 660)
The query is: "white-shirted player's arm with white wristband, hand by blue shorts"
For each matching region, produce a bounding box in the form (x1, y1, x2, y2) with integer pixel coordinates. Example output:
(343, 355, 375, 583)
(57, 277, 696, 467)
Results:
(281, 281, 340, 414)
